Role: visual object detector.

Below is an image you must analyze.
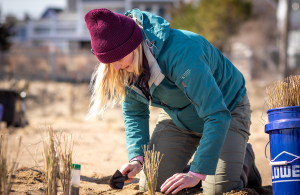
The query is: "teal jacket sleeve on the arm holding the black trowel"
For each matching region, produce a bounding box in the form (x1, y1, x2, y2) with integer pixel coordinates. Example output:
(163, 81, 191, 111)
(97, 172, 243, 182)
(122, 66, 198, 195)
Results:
(122, 91, 150, 161)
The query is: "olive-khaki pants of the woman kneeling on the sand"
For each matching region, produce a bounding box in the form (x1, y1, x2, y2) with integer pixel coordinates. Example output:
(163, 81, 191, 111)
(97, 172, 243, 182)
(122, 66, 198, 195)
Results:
(140, 94, 252, 195)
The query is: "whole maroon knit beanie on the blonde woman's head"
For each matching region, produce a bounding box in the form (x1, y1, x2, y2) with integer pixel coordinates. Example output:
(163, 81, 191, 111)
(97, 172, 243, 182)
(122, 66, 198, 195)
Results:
(84, 8, 143, 63)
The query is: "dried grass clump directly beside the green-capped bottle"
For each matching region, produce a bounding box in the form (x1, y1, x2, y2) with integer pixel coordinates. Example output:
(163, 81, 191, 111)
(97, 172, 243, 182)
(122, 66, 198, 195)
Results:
(56, 131, 75, 195)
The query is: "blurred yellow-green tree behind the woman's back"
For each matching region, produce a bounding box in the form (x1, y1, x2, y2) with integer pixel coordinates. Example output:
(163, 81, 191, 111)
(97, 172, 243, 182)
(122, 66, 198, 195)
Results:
(171, 0, 251, 51)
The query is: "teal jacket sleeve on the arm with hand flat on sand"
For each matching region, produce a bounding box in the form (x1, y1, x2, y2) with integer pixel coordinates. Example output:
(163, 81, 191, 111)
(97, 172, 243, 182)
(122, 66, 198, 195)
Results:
(166, 41, 231, 175)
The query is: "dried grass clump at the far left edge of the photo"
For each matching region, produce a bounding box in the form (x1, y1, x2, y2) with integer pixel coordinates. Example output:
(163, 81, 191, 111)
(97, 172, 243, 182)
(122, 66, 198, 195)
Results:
(0, 135, 22, 195)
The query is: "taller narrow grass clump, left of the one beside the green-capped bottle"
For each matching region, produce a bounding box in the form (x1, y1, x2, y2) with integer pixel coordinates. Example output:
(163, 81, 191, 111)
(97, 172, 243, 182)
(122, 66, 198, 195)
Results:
(43, 126, 59, 195)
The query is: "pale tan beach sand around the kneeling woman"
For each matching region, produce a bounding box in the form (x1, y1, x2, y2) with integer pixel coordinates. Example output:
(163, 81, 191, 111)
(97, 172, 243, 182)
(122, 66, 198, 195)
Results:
(0, 81, 272, 194)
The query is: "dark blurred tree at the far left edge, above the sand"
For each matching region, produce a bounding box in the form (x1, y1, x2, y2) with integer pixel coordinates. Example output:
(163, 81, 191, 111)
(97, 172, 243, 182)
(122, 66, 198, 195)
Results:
(0, 15, 17, 51)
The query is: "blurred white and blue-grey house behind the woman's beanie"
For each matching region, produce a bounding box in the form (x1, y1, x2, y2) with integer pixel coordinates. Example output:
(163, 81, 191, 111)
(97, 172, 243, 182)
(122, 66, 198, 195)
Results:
(13, 0, 178, 52)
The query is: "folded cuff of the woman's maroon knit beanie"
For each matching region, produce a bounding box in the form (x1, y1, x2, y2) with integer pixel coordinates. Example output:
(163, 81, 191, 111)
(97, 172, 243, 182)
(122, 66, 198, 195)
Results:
(94, 21, 143, 64)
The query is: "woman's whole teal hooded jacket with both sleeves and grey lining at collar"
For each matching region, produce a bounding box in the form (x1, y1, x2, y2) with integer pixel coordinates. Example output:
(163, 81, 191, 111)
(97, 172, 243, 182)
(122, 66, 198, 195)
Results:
(122, 9, 246, 175)
